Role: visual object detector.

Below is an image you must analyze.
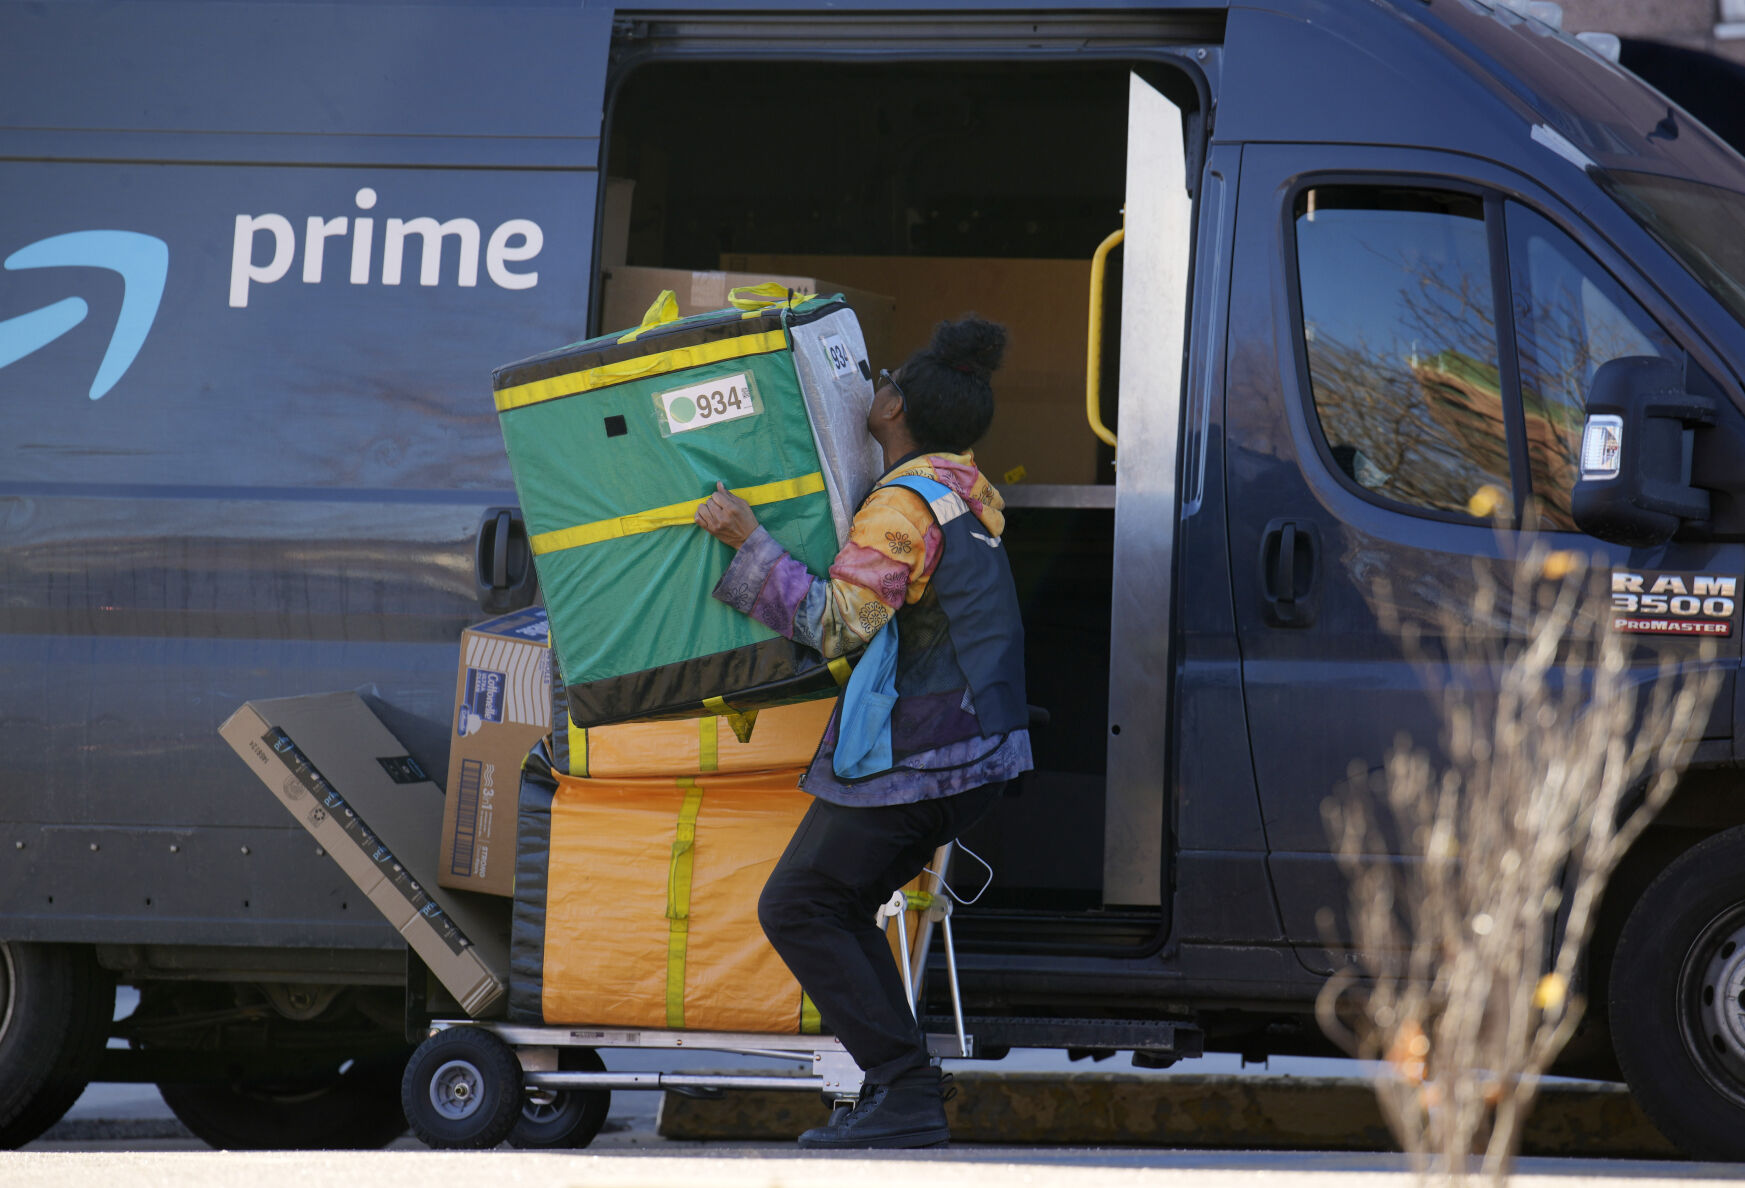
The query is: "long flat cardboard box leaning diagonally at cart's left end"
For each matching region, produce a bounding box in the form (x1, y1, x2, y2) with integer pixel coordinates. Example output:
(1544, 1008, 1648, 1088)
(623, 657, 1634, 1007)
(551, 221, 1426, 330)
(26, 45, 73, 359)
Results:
(218, 693, 513, 1017)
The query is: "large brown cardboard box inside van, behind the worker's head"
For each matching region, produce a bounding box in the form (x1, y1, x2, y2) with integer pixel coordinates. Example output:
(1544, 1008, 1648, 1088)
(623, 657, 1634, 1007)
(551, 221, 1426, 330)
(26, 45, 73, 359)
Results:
(721, 255, 1115, 487)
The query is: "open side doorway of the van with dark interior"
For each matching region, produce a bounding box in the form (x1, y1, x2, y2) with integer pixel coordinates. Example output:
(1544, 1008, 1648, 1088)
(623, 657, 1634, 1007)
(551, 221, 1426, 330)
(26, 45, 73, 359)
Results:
(595, 59, 1197, 947)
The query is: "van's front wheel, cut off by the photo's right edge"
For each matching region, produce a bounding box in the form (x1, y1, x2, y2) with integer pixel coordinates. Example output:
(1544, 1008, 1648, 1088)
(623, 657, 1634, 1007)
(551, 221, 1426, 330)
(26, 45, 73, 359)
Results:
(1609, 827, 1745, 1162)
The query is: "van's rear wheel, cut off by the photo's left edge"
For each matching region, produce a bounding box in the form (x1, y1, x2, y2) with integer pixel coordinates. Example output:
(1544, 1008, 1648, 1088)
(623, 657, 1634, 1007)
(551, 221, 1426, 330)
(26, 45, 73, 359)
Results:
(0, 940, 115, 1150)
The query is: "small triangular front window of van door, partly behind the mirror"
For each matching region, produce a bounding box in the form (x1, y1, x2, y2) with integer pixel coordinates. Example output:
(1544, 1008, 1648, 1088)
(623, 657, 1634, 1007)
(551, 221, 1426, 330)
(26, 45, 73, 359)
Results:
(1506, 202, 1682, 532)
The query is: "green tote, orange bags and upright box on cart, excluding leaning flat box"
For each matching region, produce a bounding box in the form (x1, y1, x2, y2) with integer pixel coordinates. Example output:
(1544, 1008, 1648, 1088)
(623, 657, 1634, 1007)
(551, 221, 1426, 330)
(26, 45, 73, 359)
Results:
(441, 270, 942, 1034)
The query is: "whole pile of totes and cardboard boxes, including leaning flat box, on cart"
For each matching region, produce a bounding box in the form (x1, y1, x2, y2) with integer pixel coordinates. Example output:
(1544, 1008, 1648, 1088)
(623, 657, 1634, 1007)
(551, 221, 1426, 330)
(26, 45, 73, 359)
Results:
(222, 259, 949, 1034)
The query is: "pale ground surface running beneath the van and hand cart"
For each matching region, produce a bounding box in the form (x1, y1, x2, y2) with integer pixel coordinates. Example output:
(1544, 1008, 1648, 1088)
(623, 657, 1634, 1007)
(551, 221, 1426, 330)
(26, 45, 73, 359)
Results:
(23, 991, 1745, 1188)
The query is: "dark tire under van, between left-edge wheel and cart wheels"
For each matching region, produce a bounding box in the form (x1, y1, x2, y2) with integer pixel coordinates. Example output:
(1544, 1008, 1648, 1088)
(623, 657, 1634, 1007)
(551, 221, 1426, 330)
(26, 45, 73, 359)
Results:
(157, 1054, 407, 1151)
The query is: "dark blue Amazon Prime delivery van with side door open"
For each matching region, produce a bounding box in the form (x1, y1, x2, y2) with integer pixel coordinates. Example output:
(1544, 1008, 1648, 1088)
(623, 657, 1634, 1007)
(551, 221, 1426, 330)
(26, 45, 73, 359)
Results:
(10, 0, 1745, 1158)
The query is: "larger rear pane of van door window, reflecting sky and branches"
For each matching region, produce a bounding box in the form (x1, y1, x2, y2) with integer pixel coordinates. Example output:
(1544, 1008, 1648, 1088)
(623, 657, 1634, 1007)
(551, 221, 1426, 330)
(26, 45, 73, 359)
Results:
(1295, 187, 1511, 516)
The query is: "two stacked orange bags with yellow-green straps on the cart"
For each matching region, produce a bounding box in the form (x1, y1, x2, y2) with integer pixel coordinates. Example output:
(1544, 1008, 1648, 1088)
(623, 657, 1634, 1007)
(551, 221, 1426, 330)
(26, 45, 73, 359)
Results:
(510, 686, 834, 1033)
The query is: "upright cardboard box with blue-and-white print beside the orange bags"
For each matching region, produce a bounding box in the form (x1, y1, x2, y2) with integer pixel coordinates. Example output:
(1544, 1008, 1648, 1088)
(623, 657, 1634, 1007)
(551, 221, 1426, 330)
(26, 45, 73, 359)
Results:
(436, 607, 551, 895)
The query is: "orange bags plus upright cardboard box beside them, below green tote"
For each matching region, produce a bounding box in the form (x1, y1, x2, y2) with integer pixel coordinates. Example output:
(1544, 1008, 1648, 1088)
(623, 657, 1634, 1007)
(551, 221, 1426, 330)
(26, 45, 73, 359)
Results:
(438, 607, 851, 1033)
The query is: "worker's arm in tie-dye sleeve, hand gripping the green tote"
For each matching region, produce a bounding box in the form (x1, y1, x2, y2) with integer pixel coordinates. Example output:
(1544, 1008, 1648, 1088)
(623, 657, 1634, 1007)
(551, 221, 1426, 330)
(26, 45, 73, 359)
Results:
(698, 487, 942, 659)
